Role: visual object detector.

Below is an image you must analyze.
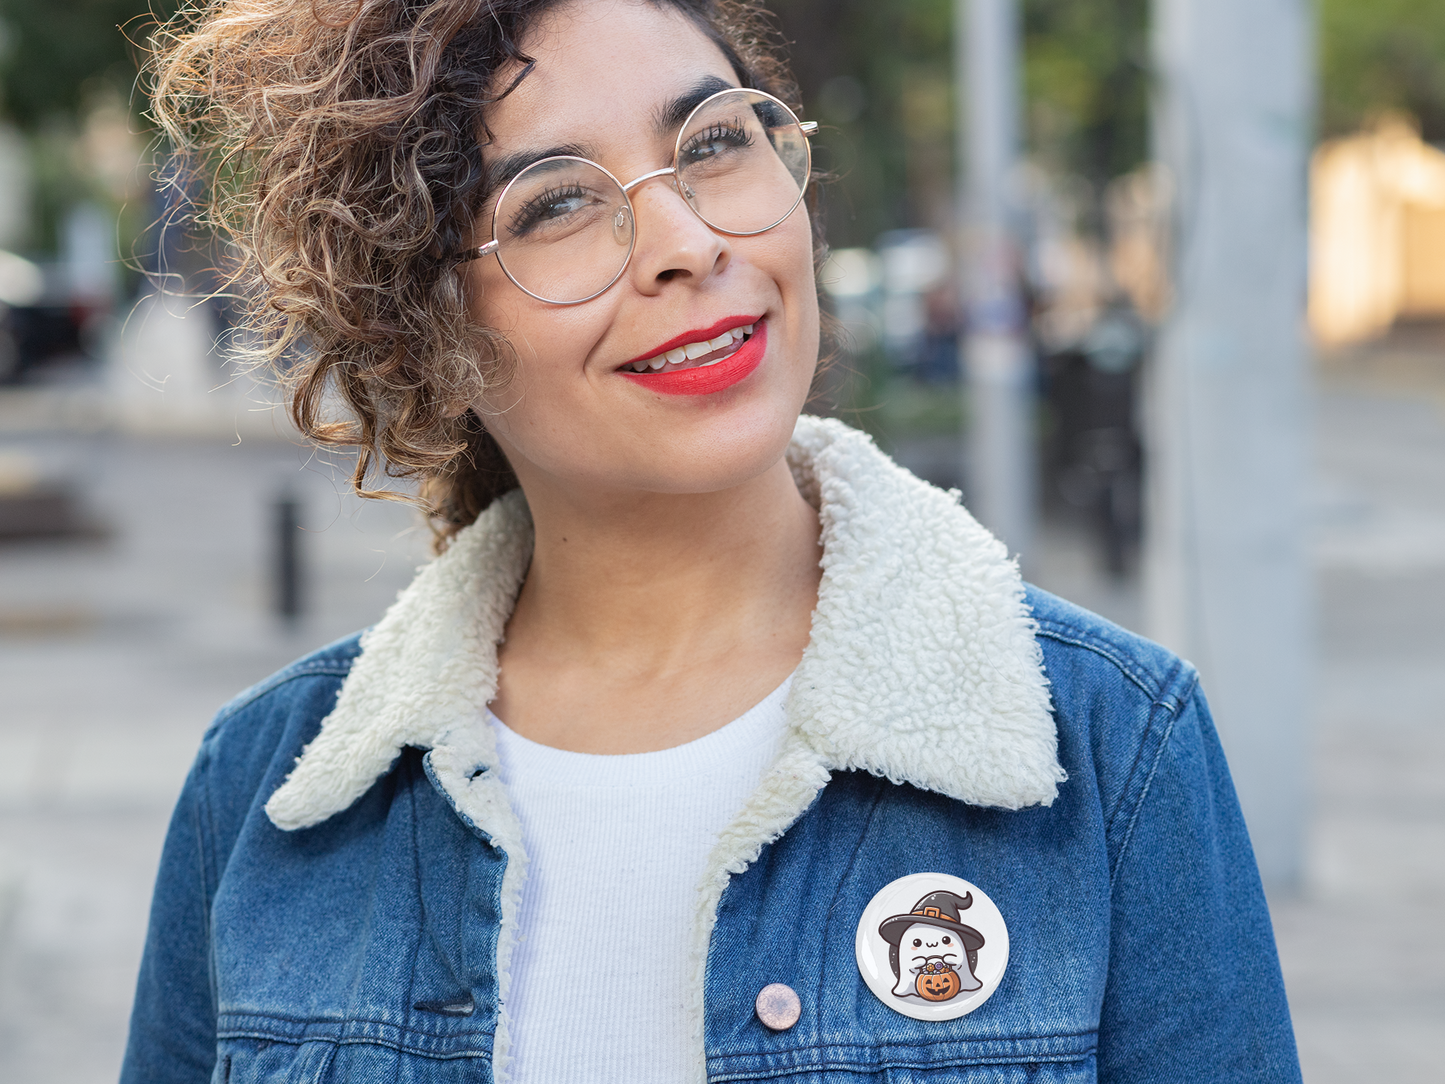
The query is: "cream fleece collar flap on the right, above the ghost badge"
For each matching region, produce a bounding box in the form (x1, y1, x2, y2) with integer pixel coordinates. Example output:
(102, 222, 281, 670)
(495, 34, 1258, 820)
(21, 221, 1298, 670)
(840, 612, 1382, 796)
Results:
(789, 419, 1064, 809)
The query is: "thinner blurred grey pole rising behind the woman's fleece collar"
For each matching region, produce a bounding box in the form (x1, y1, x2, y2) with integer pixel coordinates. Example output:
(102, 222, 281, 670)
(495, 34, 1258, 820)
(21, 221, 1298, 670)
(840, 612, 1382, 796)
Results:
(954, 0, 1035, 554)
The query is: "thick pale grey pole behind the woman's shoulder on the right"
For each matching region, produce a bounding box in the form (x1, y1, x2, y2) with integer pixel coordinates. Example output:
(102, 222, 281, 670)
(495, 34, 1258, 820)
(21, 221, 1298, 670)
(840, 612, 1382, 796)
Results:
(1144, 0, 1314, 889)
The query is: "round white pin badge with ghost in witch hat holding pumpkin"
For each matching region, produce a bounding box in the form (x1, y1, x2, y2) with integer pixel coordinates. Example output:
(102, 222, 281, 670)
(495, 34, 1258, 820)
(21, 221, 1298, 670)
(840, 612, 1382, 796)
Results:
(854, 873, 1009, 1020)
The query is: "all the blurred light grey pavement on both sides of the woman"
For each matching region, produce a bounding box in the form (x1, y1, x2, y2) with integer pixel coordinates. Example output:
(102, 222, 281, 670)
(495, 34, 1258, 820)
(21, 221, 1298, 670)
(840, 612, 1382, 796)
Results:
(0, 350, 1445, 1084)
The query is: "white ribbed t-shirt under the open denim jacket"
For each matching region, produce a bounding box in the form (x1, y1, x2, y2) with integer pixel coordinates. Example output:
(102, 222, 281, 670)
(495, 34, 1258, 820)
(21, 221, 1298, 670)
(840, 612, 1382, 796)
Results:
(488, 678, 792, 1084)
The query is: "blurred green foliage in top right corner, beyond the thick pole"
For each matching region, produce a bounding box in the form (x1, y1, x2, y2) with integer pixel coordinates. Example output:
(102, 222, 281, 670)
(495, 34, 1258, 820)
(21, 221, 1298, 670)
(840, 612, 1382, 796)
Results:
(1318, 0, 1445, 143)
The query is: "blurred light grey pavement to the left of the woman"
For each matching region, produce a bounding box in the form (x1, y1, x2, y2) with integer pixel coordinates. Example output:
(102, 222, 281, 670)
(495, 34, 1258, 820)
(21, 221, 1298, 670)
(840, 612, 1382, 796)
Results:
(0, 434, 429, 1084)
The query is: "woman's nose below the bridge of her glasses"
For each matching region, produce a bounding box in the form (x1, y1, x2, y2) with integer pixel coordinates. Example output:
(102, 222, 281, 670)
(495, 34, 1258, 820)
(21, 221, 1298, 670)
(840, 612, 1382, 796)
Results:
(629, 173, 733, 293)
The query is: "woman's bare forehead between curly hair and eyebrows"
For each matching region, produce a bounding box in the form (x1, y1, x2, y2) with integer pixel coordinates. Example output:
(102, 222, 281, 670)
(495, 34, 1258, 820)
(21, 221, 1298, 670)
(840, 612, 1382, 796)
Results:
(486, 0, 737, 152)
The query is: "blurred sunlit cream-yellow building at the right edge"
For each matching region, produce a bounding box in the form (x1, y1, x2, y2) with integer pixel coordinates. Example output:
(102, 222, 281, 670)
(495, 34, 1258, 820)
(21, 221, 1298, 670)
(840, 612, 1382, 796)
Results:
(1309, 117, 1445, 345)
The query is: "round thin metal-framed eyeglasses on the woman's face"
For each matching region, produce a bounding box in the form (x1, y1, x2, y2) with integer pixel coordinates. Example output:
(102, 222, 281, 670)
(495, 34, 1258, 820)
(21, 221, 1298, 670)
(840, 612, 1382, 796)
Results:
(462, 90, 818, 305)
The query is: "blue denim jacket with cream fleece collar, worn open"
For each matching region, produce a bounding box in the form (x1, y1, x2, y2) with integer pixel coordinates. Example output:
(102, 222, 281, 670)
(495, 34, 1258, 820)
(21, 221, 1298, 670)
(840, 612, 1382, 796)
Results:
(121, 418, 1299, 1084)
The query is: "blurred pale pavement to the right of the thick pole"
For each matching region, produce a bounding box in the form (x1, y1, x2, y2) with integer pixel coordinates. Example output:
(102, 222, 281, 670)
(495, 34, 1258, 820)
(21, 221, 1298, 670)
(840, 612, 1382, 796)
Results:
(1273, 335, 1445, 1084)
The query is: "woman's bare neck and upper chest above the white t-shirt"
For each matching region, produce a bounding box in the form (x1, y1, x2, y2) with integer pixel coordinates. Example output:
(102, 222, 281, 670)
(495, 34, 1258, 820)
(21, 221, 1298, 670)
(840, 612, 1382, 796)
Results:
(493, 460, 822, 752)
